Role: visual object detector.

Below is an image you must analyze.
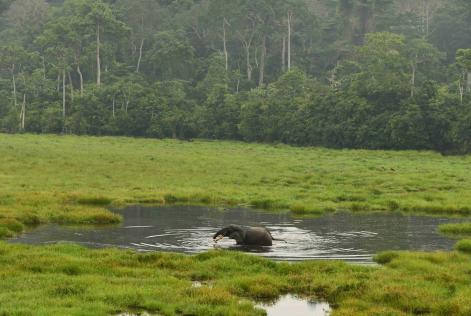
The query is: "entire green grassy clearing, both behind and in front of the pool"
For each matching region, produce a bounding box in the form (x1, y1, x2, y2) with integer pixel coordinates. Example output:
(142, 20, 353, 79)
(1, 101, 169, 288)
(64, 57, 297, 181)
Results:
(0, 134, 471, 315)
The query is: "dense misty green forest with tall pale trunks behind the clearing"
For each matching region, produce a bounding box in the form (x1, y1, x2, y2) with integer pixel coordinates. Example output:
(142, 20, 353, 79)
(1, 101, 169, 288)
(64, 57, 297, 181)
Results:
(0, 0, 471, 154)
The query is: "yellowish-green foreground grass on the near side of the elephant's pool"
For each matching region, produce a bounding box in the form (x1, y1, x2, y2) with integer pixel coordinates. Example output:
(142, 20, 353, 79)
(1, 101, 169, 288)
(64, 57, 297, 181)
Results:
(0, 242, 471, 315)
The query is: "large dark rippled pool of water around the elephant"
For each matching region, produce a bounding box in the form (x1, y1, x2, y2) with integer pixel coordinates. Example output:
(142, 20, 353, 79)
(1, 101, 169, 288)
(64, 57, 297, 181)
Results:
(11, 206, 457, 263)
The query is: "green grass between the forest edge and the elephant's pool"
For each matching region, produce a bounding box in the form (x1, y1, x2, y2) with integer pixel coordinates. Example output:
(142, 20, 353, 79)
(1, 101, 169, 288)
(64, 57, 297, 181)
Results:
(0, 134, 471, 236)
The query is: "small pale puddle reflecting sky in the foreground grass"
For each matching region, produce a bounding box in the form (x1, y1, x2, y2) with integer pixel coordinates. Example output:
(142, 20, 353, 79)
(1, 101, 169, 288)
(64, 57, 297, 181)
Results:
(257, 295, 332, 316)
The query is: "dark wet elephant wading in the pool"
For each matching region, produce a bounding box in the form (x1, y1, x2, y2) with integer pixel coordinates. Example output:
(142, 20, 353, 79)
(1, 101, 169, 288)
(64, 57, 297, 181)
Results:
(213, 225, 284, 246)
